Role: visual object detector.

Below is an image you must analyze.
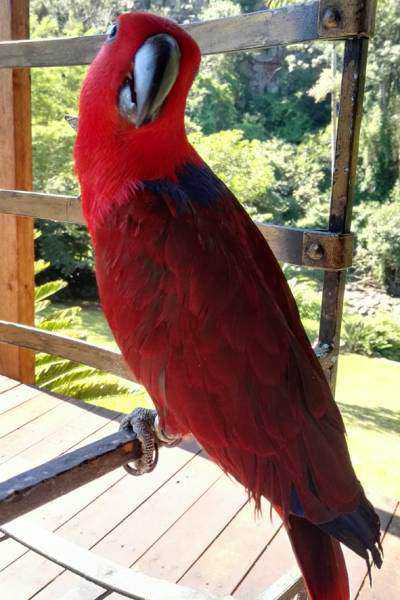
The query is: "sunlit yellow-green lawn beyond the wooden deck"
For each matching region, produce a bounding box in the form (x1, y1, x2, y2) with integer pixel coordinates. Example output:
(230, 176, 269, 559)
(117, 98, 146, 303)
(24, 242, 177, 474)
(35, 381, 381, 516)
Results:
(45, 303, 400, 498)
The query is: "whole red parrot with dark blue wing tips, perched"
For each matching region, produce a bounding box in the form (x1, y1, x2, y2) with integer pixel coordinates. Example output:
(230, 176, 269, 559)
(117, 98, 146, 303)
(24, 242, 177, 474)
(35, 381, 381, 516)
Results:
(75, 13, 381, 600)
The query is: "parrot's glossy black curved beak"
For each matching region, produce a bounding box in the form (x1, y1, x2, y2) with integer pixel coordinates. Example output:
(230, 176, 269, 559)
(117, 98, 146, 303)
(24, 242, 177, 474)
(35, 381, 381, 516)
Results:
(118, 33, 181, 127)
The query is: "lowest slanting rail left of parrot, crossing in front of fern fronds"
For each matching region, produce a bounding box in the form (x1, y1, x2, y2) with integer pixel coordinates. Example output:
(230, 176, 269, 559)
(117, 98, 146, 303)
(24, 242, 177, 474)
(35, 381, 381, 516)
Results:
(0, 320, 135, 381)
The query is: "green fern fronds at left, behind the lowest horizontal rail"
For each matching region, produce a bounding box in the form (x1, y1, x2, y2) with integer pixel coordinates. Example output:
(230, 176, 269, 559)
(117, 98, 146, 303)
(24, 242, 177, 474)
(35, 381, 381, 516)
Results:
(35, 245, 134, 410)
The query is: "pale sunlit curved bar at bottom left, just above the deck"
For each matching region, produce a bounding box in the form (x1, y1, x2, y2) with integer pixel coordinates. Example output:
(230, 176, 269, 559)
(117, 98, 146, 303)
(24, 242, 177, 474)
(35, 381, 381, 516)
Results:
(2, 519, 219, 600)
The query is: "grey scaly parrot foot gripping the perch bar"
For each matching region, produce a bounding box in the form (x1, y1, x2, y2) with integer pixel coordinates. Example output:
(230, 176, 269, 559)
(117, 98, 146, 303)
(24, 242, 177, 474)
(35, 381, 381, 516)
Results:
(120, 408, 181, 476)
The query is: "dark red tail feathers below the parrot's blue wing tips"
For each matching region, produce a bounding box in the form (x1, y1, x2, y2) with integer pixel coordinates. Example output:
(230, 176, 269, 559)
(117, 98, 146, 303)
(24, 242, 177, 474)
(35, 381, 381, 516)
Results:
(287, 515, 350, 600)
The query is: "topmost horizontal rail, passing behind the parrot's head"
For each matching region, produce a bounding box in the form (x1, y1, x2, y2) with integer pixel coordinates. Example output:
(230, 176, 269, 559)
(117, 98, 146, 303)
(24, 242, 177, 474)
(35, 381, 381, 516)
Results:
(0, 0, 376, 67)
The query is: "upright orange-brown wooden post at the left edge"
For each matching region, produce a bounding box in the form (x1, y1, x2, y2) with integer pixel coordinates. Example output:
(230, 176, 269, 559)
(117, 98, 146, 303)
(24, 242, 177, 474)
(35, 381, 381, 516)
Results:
(0, 0, 34, 383)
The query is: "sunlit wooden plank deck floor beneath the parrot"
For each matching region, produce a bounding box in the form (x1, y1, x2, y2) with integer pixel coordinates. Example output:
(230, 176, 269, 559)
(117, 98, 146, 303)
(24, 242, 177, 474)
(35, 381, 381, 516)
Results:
(0, 376, 400, 600)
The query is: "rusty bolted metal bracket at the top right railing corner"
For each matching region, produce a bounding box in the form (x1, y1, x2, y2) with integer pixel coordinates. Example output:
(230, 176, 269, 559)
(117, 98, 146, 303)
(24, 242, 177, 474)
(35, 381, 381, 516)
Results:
(318, 0, 376, 39)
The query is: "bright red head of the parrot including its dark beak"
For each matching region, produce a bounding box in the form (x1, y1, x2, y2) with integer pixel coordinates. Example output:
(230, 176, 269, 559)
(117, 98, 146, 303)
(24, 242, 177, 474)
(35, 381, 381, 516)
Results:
(75, 12, 200, 184)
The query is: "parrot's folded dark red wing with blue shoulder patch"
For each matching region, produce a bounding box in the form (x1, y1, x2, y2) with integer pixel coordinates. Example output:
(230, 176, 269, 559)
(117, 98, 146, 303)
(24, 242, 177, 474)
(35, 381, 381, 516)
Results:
(119, 165, 360, 520)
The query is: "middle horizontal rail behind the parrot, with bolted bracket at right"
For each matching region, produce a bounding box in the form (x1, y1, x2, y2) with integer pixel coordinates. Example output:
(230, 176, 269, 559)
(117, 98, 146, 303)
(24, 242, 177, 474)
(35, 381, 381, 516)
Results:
(0, 189, 353, 270)
